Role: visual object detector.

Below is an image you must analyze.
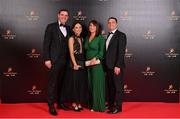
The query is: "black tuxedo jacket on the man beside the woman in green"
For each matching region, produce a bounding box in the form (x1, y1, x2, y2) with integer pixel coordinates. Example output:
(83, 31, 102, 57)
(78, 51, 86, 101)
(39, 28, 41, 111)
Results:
(105, 30, 127, 69)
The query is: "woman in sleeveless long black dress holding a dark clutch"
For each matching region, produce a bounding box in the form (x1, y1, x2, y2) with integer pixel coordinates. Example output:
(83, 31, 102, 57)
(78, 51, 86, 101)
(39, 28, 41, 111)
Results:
(62, 22, 88, 111)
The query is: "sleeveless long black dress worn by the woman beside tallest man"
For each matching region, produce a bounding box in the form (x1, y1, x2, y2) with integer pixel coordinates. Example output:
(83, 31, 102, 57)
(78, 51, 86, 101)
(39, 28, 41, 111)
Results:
(62, 36, 88, 104)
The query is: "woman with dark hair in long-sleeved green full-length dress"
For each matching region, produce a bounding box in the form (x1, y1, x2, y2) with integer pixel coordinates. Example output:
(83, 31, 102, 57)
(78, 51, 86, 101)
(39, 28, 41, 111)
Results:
(84, 20, 105, 112)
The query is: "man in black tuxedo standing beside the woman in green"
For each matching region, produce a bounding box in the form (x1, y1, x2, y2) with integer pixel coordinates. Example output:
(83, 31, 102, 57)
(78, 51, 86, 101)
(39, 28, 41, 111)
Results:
(105, 17, 127, 114)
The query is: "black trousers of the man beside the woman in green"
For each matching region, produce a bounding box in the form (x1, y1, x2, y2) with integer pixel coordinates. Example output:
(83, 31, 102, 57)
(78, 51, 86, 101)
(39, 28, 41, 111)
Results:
(106, 68, 124, 108)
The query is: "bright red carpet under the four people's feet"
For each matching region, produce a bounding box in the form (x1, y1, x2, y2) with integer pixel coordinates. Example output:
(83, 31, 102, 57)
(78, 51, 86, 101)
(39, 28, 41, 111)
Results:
(0, 102, 180, 118)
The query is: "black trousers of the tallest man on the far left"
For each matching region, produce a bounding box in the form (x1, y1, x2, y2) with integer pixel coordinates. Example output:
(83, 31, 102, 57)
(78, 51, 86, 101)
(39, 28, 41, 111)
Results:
(47, 60, 66, 106)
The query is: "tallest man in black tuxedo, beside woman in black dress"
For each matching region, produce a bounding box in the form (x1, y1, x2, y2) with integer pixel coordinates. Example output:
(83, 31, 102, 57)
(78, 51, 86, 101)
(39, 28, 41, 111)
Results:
(43, 9, 70, 115)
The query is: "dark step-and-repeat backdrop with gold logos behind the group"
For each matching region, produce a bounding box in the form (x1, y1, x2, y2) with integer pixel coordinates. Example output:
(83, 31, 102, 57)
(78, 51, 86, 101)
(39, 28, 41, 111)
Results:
(0, 0, 180, 103)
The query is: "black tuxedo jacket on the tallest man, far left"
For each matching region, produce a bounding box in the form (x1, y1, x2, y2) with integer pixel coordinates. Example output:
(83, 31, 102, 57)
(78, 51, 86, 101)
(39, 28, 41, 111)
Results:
(43, 22, 70, 62)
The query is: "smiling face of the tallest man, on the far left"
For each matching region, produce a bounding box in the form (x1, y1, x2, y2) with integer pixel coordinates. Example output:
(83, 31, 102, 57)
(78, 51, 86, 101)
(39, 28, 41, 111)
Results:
(58, 11, 69, 24)
